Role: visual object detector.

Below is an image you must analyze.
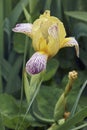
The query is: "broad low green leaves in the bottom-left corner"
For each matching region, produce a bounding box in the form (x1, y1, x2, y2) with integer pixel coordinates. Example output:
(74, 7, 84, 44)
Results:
(0, 94, 43, 130)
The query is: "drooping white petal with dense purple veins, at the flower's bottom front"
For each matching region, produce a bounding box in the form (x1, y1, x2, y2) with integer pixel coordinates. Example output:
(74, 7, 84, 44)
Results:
(26, 52, 48, 75)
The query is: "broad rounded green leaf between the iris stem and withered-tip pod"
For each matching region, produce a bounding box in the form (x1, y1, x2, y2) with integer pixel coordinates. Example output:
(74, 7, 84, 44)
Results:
(32, 86, 62, 123)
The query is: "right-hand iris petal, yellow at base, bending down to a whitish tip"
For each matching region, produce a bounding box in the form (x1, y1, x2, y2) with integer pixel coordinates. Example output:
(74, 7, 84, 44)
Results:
(60, 37, 79, 57)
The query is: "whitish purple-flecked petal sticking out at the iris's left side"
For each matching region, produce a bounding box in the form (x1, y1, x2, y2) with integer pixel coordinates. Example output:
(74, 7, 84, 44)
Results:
(12, 23, 32, 36)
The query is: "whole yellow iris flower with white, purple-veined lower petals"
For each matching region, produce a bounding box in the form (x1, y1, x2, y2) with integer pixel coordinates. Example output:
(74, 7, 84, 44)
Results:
(13, 10, 79, 74)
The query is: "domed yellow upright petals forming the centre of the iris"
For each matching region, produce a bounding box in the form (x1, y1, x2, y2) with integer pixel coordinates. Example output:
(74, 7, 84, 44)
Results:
(32, 11, 66, 57)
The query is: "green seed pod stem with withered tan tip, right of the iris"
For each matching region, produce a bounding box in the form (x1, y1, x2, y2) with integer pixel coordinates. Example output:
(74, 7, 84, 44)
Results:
(54, 71, 77, 122)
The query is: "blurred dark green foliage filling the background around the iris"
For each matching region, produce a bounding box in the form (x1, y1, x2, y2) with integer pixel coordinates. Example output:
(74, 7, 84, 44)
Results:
(0, 0, 87, 130)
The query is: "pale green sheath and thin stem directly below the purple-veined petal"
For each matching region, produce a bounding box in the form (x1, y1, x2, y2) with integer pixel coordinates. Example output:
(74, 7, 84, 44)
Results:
(18, 73, 43, 130)
